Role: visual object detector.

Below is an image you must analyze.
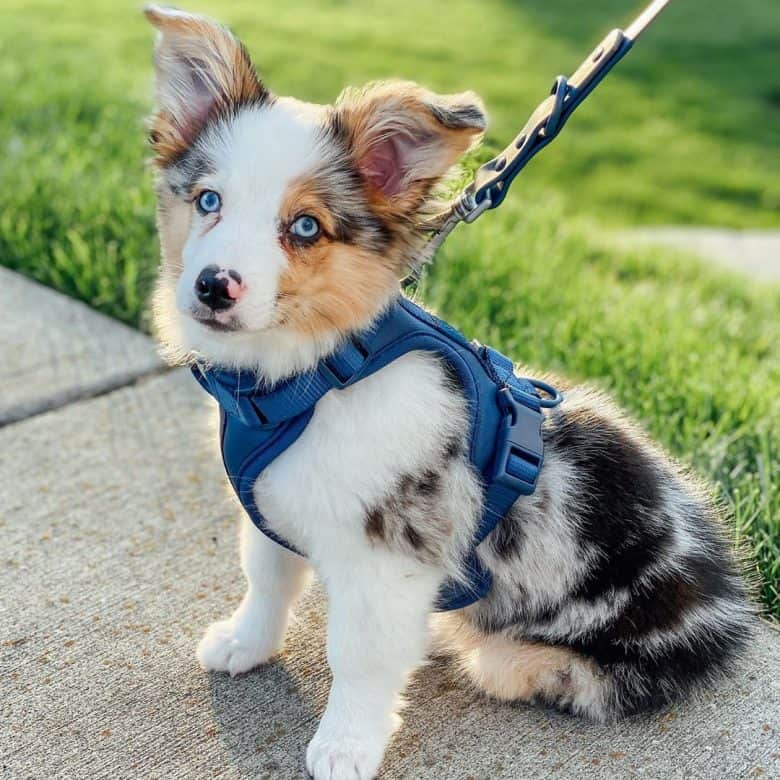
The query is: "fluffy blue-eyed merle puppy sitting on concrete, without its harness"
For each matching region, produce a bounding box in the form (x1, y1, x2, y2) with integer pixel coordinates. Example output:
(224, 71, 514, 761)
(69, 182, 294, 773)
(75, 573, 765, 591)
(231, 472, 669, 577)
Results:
(145, 7, 751, 780)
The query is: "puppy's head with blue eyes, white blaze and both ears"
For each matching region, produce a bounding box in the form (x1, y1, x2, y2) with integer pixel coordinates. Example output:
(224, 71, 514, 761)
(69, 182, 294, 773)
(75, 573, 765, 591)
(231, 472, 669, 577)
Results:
(145, 7, 485, 373)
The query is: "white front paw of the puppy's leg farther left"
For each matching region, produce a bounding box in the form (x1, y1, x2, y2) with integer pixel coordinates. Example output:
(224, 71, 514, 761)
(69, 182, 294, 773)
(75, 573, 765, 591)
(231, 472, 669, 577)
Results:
(197, 618, 281, 677)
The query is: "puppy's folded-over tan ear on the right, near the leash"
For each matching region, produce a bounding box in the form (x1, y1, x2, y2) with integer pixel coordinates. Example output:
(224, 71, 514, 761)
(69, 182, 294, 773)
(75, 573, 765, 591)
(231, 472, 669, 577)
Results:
(335, 82, 487, 211)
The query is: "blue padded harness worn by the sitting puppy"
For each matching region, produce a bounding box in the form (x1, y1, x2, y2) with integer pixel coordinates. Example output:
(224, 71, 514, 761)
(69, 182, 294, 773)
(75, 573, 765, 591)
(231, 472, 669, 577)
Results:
(192, 297, 562, 611)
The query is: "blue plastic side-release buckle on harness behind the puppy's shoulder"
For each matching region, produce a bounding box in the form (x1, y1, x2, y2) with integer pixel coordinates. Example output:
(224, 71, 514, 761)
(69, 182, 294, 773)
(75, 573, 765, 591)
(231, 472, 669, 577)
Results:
(490, 387, 544, 495)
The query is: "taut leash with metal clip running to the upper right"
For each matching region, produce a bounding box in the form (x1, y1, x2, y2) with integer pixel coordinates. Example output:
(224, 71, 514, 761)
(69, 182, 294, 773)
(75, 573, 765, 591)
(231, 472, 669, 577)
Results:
(402, 0, 671, 287)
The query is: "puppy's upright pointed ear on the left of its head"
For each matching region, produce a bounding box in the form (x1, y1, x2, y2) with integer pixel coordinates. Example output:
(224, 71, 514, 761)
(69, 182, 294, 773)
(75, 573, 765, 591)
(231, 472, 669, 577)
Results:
(144, 6, 269, 165)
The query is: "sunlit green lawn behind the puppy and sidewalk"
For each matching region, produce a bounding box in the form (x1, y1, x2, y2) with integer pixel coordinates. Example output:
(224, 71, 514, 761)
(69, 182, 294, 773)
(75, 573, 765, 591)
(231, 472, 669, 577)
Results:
(0, 0, 780, 617)
